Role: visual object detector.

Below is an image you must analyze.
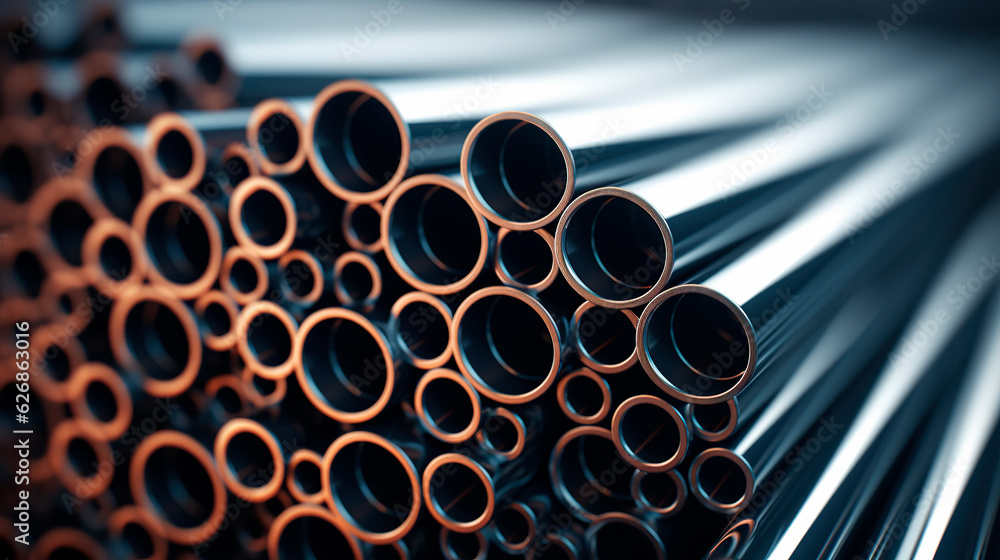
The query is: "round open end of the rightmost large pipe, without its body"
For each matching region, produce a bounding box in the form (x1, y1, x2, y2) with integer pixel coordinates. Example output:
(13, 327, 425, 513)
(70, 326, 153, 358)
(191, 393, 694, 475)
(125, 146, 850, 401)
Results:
(636, 284, 757, 404)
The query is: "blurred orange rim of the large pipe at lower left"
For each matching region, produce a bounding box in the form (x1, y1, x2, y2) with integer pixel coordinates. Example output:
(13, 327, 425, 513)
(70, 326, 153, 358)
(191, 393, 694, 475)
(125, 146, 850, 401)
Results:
(129, 430, 226, 545)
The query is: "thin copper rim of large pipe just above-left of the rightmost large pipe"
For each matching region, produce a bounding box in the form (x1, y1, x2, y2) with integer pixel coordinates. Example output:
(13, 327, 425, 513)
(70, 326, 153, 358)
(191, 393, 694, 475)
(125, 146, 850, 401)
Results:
(556, 187, 674, 309)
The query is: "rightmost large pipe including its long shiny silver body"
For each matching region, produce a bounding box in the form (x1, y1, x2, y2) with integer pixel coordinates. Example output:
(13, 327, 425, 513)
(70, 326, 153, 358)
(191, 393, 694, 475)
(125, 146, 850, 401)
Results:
(636, 76, 998, 404)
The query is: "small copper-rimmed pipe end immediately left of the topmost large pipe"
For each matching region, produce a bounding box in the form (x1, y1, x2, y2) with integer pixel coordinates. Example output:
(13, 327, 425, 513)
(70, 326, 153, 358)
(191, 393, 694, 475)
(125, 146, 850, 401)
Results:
(247, 99, 306, 175)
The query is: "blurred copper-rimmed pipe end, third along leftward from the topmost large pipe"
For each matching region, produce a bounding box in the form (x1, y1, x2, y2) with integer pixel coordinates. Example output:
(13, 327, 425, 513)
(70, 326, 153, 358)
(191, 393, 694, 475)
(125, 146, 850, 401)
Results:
(73, 127, 154, 221)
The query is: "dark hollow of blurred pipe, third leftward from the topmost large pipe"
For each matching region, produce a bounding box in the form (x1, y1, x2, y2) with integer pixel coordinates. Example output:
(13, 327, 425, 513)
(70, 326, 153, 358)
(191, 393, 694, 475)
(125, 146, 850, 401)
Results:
(92, 145, 146, 221)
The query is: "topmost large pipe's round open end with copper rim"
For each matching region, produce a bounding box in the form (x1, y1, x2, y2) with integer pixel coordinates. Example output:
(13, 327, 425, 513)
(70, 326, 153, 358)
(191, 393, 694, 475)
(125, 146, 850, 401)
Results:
(309, 80, 410, 202)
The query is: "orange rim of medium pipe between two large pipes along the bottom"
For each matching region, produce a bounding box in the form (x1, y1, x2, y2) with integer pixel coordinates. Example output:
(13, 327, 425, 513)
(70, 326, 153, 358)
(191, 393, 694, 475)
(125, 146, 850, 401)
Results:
(215, 418, 285, 502)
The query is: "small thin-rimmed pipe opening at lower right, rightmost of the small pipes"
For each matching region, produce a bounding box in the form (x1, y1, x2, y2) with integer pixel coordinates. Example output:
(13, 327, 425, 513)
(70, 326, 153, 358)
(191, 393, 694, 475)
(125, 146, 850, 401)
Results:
(690, 448, 754, 514)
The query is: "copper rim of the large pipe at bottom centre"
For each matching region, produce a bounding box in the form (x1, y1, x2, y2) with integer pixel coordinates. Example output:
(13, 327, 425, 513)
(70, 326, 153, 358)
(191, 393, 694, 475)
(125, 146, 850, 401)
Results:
(321, 431, 421, 544)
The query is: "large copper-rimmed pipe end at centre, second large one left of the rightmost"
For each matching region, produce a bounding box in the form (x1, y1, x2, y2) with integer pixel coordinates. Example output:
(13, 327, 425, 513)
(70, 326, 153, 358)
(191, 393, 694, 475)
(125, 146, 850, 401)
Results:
(451, 286, 562, 404)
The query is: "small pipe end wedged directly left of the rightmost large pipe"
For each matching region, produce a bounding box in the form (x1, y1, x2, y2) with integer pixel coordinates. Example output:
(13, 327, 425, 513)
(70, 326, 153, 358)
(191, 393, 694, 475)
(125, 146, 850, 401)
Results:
(570, 301, 639, 374)
